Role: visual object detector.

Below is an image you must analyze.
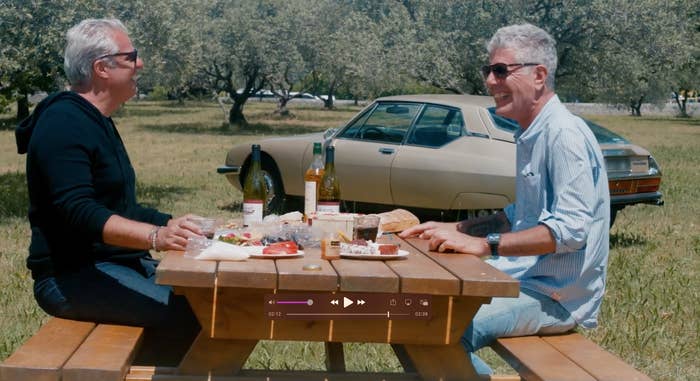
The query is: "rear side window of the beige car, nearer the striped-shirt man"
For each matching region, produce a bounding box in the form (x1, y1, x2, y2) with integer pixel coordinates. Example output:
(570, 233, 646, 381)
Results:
(407, 105, 465, 147)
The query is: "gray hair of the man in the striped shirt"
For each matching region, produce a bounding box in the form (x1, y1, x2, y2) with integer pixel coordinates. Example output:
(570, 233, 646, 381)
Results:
(486, 24, 557, 90)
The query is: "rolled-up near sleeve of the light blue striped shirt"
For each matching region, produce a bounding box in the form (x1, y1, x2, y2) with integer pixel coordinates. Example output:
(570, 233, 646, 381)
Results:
(538, 129, 596, 253)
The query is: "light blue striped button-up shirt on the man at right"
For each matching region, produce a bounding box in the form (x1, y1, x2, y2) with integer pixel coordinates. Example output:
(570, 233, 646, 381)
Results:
(488, 95, 610, 328)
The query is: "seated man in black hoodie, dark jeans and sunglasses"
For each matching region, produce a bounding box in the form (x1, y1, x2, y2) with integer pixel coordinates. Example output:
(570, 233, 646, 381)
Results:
(16, 19, 202, 365)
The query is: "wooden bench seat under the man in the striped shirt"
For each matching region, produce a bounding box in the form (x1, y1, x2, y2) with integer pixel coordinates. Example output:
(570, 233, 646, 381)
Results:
(491, 332, 651, 381)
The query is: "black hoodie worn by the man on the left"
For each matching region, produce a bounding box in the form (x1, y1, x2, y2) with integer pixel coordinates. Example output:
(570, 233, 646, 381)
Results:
(15, 91, 171, 279)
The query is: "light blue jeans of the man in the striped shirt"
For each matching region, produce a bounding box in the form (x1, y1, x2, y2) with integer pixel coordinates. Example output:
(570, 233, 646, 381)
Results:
(462, 288, 576, 374)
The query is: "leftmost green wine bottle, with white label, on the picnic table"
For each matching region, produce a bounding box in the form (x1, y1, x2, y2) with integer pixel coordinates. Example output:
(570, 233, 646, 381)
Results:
(243, 144, 267, 226)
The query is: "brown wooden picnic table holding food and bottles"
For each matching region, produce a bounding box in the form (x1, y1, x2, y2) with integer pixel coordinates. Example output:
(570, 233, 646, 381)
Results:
(157, 235, 519, 380)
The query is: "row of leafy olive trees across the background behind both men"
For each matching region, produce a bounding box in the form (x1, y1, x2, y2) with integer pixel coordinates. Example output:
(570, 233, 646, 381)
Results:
(0, 0, 700, 125)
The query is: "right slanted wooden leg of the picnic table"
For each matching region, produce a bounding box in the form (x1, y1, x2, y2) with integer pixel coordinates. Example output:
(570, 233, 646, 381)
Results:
(404, 343, 480, 381)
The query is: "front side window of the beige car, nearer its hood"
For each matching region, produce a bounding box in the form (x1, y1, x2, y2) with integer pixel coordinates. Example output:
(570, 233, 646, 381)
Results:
(339, 103, 421, 143)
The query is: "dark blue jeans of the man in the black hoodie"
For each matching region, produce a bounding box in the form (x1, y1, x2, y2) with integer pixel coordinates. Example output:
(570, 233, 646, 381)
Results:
(34, 258, 200, 366)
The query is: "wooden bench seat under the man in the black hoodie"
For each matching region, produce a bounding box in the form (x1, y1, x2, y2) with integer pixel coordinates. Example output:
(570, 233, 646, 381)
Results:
(0, 318, 143, 381)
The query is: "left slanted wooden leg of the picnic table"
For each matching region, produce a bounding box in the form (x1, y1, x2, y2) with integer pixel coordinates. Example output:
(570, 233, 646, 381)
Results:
(178, 331, 257, 375)
